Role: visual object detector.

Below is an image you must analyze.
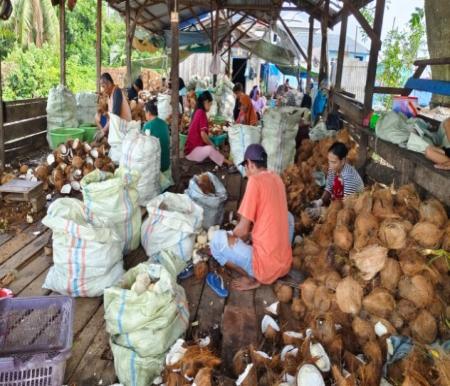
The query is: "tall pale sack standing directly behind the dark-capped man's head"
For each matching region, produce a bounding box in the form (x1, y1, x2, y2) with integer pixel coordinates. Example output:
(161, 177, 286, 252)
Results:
(262, 107, 308, 174)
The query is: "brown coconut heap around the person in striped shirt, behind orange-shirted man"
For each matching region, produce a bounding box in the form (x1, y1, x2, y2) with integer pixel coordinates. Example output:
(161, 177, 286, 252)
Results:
(282, 129, 357, 222)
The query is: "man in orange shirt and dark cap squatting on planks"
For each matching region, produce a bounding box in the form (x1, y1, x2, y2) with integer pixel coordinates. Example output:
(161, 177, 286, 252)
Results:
(211, 144, 294, 290)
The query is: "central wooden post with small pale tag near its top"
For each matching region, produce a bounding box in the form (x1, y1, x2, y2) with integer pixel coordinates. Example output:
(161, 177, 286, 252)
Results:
(170, 0, 180, 186)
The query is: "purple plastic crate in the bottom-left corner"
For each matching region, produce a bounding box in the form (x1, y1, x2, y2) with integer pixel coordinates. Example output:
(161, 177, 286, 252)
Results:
(0, 296, 73, 386)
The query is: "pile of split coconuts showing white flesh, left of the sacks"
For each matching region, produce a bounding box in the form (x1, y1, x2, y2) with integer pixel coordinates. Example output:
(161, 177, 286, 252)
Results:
(25, 138, 115, 194)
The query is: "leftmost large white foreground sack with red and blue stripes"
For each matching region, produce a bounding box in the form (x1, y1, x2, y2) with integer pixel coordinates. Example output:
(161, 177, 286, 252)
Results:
(42, 198, 124, 297)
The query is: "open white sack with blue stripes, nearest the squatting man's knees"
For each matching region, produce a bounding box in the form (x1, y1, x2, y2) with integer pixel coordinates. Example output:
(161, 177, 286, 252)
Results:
(141, 192, 203, 274)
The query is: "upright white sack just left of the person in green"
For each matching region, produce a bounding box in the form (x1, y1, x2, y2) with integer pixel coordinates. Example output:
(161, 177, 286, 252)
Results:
(120, 130, 161, 206)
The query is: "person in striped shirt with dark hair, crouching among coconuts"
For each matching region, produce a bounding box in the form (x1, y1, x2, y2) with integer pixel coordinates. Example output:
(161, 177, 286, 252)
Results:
(308, 142, 364, 217)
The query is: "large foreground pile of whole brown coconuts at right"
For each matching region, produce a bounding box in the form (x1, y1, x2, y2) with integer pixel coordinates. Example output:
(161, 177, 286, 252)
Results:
(270, 185, 450, 386)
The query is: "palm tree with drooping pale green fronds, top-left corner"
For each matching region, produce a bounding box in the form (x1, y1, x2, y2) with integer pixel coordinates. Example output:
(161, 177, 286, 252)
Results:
(3, 0, 59, 48)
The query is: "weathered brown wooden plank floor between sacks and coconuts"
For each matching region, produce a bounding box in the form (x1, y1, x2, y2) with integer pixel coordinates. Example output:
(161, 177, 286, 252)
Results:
(0, 168, 273, 386)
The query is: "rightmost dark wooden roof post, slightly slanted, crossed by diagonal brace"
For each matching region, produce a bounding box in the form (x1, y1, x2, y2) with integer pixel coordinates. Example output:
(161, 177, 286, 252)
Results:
(364, 0, 386, 114)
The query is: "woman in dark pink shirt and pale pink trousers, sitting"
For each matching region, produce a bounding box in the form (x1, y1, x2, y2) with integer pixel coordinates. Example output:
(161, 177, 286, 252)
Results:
(184, 91, 232, 166)
